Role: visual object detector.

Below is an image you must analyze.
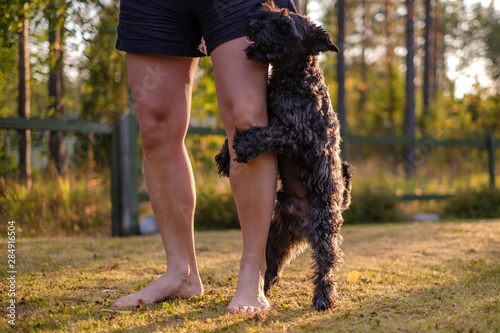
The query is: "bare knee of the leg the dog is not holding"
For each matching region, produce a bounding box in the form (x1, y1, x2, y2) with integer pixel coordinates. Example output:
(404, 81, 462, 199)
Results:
(138, 104, 186, 155)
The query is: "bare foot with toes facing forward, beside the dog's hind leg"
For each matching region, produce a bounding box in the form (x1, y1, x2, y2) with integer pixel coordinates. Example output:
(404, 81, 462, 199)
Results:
(227, 263, 270, 314)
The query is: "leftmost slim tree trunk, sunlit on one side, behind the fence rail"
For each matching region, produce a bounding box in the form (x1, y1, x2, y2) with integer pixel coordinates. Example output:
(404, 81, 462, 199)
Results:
(17, 3, 31, 187)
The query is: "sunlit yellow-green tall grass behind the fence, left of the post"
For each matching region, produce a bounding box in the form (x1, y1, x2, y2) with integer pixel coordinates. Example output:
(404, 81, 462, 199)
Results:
(0, 170, 111, 237)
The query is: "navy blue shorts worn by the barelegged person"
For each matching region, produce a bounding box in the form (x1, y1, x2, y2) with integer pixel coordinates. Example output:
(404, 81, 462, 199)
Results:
(116, 0, 296, 57)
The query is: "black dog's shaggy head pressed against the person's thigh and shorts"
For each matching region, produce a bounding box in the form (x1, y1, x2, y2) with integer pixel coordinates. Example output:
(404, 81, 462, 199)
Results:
(245, 1, 339, 64)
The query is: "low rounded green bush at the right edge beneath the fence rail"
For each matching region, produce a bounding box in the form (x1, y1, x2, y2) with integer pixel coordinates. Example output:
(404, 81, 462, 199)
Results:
(444, 187, 500, 219)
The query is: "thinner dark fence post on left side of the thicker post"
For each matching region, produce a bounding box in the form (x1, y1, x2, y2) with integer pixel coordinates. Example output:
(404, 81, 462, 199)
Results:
(110, 122, 123, 237)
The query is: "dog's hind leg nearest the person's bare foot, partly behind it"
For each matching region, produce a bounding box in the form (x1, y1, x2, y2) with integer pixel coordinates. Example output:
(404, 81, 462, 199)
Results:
(264, 202, 306, 294)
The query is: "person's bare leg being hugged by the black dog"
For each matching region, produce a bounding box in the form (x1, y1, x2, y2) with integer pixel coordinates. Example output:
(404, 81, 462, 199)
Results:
(212, 38, 277, 313)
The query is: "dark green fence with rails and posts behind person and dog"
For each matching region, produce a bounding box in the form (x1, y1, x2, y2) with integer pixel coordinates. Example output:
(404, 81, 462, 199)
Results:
(0, 114, 500, 236)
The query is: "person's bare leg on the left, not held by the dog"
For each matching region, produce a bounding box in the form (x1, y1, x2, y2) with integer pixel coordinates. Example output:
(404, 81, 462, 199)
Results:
(113, 54, 203, 306)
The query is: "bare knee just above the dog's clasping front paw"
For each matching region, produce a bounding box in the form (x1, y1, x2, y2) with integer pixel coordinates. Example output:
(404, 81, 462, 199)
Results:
(232, 102, 267, 130)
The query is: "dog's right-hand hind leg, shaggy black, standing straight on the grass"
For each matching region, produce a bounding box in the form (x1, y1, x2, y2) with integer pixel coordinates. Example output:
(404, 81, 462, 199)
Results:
(308, 203, 343, 311)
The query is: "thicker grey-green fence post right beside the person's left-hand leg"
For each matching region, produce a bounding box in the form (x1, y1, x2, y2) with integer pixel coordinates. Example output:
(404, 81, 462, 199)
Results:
(120, 113, 139, 235)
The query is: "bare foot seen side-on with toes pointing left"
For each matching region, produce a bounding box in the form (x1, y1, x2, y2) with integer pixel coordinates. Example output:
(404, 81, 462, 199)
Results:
(112, 267, 203, 307)
